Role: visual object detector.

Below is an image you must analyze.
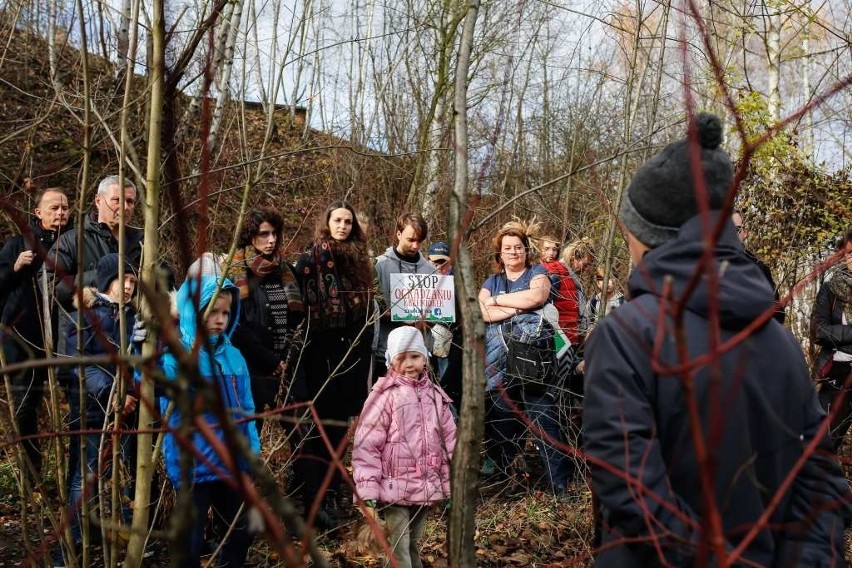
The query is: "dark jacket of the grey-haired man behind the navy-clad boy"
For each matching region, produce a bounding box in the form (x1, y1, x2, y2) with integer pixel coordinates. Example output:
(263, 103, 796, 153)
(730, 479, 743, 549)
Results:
(44, 215, 142, 311)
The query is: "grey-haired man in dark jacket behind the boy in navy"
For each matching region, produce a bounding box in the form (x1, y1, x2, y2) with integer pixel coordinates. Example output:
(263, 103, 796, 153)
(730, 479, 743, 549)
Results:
(44, 176, 142, 313)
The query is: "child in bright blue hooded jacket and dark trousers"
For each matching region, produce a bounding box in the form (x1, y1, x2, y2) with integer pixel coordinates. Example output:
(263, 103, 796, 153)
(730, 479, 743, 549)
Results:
(160, 276, 260, 567)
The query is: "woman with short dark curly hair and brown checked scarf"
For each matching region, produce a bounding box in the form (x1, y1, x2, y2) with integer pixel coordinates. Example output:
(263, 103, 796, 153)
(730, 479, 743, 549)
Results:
(228, 208, 304, 412)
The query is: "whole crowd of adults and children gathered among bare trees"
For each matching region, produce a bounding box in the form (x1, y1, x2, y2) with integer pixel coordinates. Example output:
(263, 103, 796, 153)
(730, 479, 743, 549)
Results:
(0, 115, 852, 566)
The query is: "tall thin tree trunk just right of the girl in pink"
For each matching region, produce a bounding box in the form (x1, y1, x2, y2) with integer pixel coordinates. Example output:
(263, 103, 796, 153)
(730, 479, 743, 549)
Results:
(448, 4, 485, 566)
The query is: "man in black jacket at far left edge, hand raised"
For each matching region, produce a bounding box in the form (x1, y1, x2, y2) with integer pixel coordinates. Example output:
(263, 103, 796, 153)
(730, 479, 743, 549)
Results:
(0, 187, 69, 474)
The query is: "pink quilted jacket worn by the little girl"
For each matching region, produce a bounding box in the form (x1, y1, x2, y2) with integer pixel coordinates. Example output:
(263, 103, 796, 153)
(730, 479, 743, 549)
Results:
(352, 370, 456, 505)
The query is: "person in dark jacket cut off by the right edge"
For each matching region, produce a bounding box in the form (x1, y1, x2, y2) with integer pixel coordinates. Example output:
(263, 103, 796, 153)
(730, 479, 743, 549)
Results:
(811, 229, 852, 450)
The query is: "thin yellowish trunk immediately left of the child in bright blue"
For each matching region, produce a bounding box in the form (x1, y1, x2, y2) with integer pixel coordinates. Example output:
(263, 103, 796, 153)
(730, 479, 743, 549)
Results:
(126, 0, 166, 568)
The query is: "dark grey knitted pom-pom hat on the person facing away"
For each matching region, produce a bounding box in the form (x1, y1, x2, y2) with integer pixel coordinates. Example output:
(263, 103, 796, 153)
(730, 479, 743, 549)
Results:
(619, 113, 734, 248)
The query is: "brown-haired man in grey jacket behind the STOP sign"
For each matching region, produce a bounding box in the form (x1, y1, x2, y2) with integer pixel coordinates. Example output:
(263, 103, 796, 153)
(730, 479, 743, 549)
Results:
(373, 213, 437, 378)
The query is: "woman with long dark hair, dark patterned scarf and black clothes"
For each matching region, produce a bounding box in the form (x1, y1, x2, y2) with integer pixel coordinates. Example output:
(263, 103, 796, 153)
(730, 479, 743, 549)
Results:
(296, 201, 373, 530)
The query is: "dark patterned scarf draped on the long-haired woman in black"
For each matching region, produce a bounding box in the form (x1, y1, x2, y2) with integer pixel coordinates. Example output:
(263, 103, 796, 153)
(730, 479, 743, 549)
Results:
(297, 240, 370, 330)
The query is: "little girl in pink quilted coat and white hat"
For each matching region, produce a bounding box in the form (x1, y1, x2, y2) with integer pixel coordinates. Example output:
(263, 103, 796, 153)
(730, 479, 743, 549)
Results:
(352, 326, 456, 568)
